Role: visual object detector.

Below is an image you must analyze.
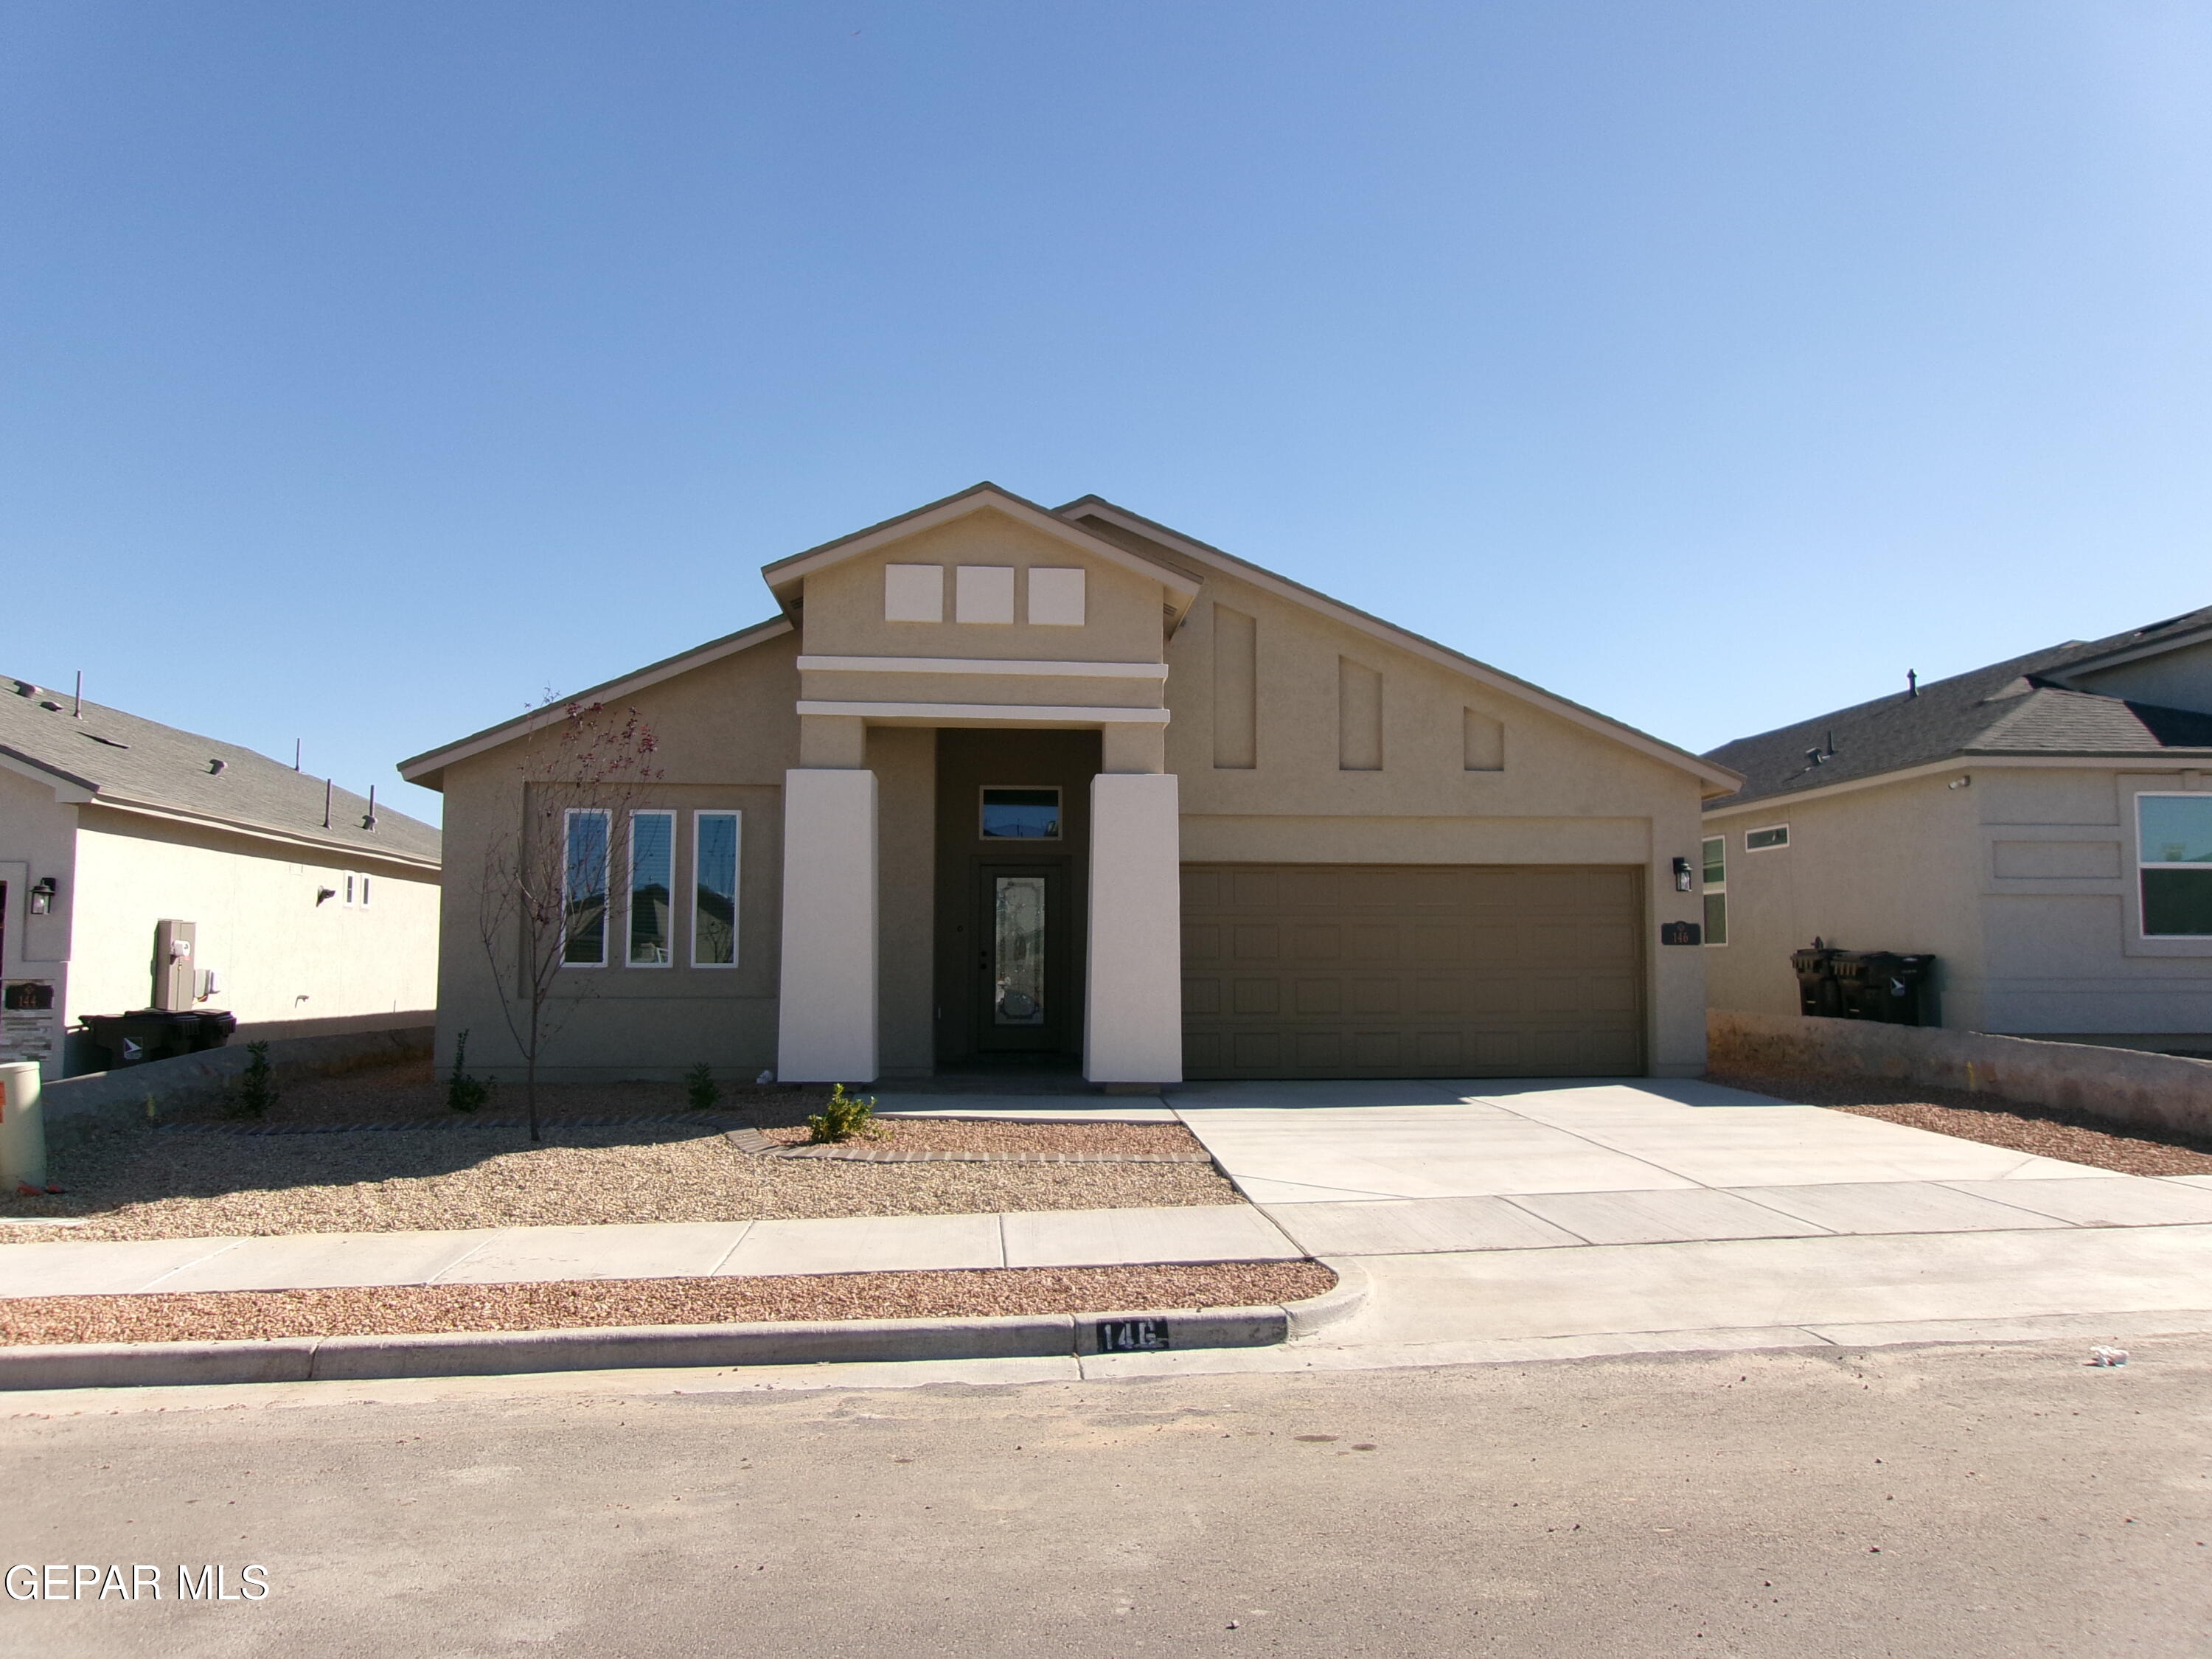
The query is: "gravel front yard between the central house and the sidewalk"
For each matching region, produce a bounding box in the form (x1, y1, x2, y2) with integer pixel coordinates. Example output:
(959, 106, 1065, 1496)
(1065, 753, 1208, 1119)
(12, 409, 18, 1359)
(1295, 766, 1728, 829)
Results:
(0, 1062, 1241, 1248)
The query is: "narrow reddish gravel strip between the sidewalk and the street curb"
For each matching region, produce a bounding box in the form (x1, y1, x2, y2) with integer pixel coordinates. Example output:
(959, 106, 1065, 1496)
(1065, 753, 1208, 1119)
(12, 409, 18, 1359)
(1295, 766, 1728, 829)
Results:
(0, 1261, 1336, 1343)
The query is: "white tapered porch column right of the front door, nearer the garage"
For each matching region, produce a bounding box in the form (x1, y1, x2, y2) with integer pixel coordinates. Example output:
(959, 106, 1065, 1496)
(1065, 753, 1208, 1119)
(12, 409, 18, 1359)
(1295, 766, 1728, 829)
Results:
(1084, 772, 1183, 1084)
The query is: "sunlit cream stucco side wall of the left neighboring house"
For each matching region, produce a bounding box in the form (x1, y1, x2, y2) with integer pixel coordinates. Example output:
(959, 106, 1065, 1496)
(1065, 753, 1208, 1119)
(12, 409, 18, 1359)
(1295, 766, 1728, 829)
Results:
(69, 805, 440, 1053)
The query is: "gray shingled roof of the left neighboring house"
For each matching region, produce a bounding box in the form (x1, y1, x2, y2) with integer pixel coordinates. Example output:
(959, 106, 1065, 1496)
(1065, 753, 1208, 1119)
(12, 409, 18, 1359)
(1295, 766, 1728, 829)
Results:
(0, 677, 438, 865)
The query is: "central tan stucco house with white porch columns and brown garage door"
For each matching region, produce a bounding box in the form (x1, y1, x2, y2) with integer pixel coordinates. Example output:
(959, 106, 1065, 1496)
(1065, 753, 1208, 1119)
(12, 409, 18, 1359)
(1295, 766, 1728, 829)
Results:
(400, 484, 1736, 1084)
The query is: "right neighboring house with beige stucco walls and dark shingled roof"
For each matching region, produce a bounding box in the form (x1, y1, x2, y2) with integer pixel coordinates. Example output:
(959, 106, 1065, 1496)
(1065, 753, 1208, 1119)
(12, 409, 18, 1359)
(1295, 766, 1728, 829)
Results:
(1703, 608, 2212, 1048)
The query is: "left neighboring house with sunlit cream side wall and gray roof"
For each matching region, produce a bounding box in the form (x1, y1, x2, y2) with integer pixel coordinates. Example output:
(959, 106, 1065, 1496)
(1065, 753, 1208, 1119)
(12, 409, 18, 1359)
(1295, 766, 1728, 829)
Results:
(0, 679, 438, 1077)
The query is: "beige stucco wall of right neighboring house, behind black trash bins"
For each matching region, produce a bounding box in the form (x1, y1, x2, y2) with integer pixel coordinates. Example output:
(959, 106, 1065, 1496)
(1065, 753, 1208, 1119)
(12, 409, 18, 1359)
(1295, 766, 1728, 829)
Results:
(1705, 761, 2212, 1035)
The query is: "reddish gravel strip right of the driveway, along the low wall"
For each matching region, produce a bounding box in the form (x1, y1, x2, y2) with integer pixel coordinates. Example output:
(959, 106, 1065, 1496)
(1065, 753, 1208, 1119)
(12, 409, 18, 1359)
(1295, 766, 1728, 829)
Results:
(1705, 1071, 2212, 1175)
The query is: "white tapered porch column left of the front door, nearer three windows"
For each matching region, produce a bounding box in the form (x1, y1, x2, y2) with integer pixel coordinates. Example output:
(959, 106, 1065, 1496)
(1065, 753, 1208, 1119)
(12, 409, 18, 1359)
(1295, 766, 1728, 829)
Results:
(776, 768, 876, 1084)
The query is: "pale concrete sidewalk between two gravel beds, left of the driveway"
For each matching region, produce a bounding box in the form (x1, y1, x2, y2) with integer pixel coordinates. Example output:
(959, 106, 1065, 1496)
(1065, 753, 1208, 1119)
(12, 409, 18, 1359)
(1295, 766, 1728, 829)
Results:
(0, 1203, 1305, 1296)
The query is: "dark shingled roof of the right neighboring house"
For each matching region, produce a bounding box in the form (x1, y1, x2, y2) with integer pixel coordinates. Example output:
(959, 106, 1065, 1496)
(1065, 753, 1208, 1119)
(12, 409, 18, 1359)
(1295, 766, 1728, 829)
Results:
(1705, 606, 2212, 812)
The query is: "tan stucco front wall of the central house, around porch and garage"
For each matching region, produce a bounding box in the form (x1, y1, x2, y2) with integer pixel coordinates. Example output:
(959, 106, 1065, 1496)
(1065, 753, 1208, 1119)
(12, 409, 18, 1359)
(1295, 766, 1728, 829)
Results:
(418, 513, 1705, 1093)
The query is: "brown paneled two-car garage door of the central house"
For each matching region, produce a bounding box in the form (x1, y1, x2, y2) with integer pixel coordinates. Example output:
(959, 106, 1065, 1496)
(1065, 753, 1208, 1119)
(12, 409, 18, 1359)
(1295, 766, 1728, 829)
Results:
(1183, 865, 1644, 1077)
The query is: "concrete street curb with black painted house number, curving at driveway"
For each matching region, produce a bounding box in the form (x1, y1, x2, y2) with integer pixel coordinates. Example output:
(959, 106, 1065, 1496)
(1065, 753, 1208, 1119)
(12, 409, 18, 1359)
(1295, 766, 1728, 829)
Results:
(0, 1263, 1367, 1391)
